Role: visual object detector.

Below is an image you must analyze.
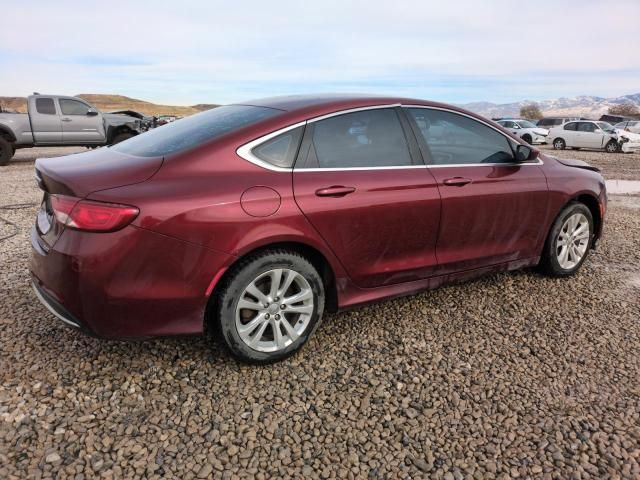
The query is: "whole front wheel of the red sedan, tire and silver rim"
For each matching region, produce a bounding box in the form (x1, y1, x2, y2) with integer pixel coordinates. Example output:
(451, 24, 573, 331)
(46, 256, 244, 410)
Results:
(540, 202, 594, 277)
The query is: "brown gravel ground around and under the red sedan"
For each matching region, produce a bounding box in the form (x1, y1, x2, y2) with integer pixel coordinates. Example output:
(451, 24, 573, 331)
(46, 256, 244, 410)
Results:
(0, 149, 640, 480)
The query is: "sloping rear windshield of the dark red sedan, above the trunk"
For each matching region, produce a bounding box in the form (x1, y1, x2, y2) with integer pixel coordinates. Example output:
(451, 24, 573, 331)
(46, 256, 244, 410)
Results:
(111, 105, 282, 157)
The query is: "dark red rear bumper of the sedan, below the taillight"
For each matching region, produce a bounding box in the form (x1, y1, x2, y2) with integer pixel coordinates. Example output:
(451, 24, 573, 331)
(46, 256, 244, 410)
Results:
(30, 226, 234, 338)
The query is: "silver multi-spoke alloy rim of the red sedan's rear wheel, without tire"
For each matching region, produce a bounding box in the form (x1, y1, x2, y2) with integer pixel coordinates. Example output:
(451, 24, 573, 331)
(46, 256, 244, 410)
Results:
(235, 268, 315, 352)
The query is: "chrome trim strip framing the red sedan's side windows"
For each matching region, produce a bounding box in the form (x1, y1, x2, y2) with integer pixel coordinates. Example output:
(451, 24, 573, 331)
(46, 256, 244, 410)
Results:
(236, 103, 544, 173)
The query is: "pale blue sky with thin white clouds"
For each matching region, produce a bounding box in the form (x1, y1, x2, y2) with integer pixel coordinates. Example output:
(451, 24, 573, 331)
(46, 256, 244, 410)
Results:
(0, 0, 640, 105)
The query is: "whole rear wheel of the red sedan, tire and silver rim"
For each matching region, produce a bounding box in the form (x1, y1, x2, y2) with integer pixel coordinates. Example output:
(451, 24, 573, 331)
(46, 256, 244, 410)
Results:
(216, 250, 325, 363)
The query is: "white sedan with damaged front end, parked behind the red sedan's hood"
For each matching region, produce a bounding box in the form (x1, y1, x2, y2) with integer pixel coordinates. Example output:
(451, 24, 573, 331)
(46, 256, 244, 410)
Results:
(548, 120, 620, 153)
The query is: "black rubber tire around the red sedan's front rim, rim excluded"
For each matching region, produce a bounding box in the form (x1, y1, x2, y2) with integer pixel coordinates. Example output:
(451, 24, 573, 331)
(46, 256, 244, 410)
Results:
(539, 202, 594, 277)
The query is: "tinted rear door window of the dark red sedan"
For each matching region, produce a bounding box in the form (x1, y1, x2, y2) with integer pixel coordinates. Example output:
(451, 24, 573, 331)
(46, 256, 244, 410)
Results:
(306, 108, 412, 168)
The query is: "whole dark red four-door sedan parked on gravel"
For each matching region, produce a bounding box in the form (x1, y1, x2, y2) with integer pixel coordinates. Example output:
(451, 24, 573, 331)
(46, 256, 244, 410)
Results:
(31, 96, 606, 362)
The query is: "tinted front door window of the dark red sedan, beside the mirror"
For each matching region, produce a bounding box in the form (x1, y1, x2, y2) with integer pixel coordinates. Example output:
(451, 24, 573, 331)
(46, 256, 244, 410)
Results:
(408, 108, 514, 165)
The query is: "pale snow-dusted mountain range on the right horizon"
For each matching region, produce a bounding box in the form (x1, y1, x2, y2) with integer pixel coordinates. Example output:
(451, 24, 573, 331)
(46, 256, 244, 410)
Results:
(462, 93, 640, 119)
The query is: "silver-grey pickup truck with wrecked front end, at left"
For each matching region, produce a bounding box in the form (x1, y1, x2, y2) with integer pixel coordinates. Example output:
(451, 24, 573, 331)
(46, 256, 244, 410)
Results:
(0, 94, 145, 165)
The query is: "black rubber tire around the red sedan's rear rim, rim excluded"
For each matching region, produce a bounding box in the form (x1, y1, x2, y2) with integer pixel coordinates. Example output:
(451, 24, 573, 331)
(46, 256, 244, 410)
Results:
(212, 250, 325, 364)
